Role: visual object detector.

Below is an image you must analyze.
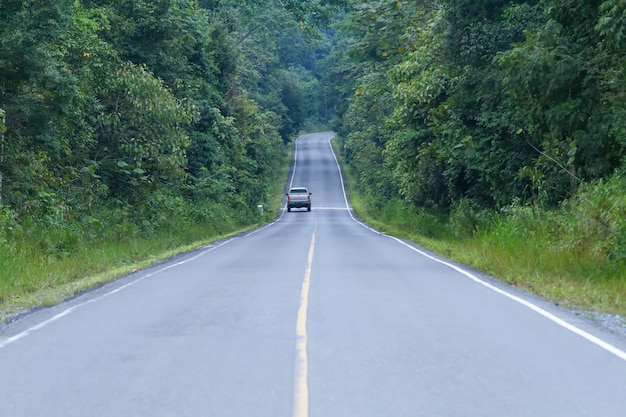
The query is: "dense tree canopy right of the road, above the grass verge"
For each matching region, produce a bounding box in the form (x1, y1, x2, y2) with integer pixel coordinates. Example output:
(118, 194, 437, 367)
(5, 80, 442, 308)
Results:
(323, 0, 626, 212)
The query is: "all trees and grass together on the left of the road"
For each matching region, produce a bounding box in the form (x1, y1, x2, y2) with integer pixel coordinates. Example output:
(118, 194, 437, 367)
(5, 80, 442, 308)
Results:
(0, 0, 341, 312)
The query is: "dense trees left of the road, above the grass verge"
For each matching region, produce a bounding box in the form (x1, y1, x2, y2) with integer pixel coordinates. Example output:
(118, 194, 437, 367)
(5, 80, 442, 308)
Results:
(0, 0, 344, 231)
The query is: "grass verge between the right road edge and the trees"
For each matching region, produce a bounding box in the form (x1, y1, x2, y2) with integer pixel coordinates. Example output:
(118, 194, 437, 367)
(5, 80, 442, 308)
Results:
(344, 145, 626, 316)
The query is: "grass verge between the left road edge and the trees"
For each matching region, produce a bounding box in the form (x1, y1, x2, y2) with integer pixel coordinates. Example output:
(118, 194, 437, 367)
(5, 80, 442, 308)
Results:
(0, 146, 293, 323)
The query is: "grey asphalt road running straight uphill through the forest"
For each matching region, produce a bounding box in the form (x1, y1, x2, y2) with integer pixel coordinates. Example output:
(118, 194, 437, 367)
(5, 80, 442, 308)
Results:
(0, 133, 626, 417)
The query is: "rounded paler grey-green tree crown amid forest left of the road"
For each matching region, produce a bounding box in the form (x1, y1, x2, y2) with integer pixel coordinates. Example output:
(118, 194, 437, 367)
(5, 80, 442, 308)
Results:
(95, 64, 193, 201)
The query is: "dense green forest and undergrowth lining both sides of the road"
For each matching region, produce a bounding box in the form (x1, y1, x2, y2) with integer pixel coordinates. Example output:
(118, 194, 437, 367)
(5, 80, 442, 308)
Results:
(0, 0, 626, 312)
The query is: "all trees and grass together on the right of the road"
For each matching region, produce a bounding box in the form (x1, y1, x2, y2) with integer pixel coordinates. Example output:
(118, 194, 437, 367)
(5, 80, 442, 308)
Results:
(325, 0, 626, 312)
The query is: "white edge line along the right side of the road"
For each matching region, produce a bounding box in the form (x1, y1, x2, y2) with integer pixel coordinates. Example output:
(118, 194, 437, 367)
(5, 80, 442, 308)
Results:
(328, 132, 626, 361)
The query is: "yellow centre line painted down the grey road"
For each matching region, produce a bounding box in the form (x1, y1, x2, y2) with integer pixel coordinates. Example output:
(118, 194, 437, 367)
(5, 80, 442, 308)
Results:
(293, 231, 315, 417)
